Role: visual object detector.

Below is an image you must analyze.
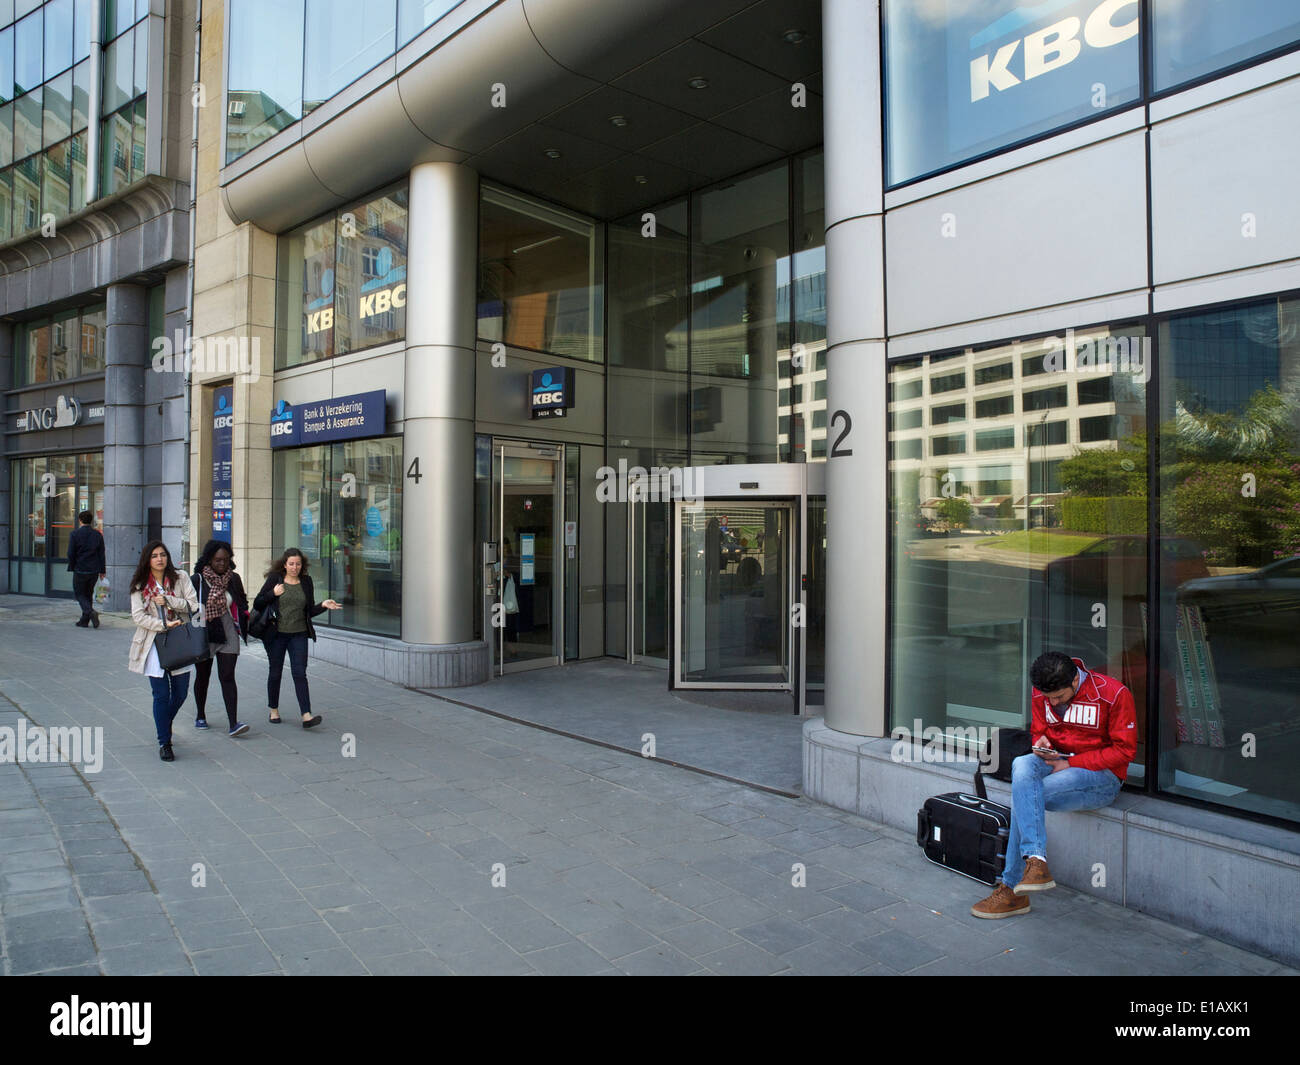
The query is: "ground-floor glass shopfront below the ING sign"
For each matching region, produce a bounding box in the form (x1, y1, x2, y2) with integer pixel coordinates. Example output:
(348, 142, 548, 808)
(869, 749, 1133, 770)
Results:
(9, 451, 104, 596)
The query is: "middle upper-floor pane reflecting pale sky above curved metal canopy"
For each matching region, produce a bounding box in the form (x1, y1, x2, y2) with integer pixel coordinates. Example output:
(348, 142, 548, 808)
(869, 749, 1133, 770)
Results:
(303, 0, 397, 114)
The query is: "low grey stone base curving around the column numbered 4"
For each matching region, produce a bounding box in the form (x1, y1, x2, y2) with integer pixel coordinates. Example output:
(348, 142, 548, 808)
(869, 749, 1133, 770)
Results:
(308, 625, 489, 688)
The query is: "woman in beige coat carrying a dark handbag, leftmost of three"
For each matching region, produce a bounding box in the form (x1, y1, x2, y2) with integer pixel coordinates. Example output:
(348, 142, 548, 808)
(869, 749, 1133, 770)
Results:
(126, 540, 199, 762)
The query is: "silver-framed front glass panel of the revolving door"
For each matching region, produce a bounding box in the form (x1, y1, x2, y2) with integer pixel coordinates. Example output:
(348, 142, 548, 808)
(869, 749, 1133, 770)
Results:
(675, 501, 796, 690)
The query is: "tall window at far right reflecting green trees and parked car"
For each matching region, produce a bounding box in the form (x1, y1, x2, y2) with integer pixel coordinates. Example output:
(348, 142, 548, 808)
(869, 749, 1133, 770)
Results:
(1160, 298, 1300, 819)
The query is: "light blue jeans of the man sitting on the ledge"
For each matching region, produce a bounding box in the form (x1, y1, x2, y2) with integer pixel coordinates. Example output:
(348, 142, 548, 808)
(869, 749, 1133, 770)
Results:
(1002, 754, 1121, 887)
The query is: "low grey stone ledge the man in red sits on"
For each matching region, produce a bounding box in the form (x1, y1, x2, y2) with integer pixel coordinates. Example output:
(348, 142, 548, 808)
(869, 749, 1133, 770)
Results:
(803, 718, 1300, 965)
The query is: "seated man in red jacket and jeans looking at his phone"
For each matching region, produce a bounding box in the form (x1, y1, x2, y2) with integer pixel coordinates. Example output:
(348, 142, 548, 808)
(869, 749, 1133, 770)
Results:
(971, 651, 1138, 919)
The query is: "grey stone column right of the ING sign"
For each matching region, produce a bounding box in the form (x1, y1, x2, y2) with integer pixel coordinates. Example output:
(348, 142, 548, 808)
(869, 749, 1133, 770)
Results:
(104, 285, 148, 610)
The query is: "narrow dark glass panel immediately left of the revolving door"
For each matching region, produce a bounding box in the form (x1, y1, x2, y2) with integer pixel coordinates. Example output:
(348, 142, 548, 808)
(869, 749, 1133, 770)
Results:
(628, 499, 672, 666)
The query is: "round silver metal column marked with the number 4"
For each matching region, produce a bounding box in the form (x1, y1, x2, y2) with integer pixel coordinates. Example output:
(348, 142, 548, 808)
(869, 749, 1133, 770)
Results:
(402, 163, 478, 644)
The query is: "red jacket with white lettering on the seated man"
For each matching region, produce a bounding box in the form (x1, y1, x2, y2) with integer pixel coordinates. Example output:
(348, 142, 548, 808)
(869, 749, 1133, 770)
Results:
(1030, 658, 1138, 782)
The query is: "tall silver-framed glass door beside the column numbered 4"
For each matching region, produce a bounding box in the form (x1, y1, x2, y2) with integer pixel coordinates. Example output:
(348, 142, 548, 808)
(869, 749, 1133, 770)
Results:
(497, 443, 564, 674)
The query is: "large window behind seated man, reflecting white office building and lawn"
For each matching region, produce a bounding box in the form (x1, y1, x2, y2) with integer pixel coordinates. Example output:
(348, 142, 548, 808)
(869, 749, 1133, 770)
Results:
(889, 321, 1147, 779)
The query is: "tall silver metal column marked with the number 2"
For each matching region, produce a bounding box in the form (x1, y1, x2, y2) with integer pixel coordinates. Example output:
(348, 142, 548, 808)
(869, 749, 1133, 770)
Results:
(822, 0, 888, 736)
